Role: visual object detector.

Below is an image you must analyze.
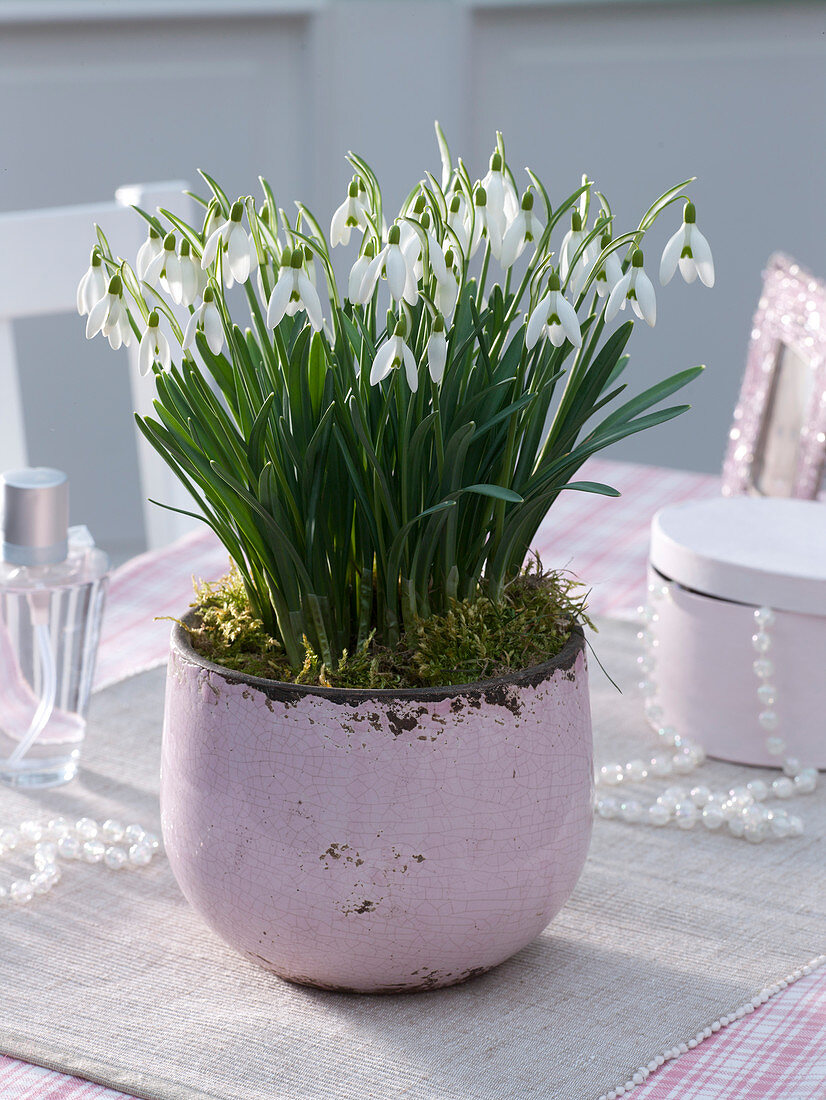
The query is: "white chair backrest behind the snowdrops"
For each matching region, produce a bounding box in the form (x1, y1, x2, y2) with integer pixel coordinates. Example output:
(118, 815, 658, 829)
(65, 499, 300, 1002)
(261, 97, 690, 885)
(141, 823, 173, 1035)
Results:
(0, 182, 196, 558)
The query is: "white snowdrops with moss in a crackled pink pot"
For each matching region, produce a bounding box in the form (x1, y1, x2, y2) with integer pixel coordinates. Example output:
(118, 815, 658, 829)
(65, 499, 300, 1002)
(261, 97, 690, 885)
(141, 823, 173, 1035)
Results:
(78, 125, 714, 991)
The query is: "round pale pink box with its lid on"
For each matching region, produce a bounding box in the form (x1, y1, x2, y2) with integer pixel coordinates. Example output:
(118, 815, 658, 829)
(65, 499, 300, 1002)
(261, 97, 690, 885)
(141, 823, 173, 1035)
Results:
(649, 496, 826, 768)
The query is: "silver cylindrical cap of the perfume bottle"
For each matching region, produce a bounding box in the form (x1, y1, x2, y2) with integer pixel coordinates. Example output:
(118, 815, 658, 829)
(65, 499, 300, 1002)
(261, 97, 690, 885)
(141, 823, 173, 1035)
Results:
(0, 466, 69, 565)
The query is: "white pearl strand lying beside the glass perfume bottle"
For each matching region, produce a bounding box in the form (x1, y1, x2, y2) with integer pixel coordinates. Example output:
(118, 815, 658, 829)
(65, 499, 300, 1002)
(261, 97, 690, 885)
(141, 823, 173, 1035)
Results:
(0, 817, 161, 905)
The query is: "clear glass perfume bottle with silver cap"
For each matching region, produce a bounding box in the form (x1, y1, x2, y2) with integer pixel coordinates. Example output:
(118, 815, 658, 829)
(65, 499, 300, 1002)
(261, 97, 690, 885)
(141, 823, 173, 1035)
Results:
(0, 466, 109, 788)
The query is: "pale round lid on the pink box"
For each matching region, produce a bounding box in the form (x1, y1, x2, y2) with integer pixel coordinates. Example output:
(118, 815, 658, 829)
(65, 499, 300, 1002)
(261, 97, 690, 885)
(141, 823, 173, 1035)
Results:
(651, 496, 826, 615)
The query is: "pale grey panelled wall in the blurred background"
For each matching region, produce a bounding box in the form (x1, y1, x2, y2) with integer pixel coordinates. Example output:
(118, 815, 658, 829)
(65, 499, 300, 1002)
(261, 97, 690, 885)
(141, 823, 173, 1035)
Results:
(0, 0, 826, 553)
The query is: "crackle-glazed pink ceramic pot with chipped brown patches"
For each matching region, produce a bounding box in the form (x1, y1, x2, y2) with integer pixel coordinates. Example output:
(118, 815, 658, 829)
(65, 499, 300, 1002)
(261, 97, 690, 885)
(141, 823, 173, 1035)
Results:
(161, 626, 593, 992)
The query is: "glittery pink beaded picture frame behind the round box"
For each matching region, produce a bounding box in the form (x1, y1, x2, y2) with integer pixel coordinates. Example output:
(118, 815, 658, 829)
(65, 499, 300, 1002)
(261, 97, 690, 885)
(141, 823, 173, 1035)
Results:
(723, 253, 826, 499)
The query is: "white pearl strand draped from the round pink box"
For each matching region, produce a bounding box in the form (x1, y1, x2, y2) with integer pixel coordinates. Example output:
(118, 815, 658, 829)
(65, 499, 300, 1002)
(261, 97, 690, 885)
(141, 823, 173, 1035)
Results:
(594, 584, 817, 844)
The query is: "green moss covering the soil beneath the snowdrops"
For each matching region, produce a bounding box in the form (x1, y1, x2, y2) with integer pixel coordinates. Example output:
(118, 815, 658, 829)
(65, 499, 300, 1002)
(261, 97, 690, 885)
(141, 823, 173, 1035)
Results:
(188, 559, 592, 688)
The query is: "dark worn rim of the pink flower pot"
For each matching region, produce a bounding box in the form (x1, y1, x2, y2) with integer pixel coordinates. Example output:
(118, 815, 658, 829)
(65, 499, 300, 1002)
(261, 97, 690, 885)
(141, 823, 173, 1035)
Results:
(172, 612, 585, 703)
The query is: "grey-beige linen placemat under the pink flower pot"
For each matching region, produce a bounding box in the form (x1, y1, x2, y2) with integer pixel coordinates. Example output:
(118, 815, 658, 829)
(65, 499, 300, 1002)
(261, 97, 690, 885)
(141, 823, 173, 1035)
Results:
(0, 623, 826, 1100)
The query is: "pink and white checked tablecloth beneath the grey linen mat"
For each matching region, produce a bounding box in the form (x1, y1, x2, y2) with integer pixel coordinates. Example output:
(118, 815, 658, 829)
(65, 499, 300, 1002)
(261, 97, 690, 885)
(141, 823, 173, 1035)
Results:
(0, 460, 826, 1100)
